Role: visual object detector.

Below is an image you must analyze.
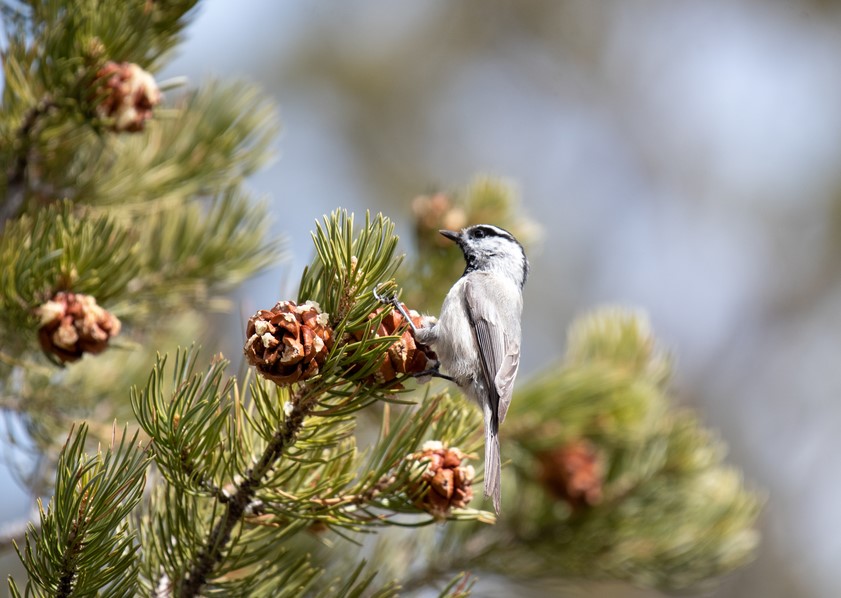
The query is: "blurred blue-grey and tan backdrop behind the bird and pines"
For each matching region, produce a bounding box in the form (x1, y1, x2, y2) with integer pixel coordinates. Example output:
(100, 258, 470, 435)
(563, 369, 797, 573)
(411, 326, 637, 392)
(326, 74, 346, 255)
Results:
(5, 0, 841, 598)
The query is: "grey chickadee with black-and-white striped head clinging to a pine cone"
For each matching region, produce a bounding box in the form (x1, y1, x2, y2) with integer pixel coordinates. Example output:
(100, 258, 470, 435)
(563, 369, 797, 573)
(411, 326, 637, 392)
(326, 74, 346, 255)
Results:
(378, 224, 529, 513)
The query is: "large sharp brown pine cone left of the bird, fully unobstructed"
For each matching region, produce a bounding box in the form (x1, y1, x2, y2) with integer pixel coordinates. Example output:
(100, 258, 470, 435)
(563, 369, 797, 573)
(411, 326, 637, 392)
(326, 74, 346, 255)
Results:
(245, 301, 333, 385)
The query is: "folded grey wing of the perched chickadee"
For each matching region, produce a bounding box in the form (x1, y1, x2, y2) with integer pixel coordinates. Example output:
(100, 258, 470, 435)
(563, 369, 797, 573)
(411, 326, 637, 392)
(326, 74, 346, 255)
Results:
(464, 277, 520, 428)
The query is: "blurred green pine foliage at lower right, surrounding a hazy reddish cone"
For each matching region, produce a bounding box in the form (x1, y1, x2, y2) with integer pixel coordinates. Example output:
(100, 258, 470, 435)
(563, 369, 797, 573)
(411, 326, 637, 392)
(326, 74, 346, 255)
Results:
(446, 308, 761, 590)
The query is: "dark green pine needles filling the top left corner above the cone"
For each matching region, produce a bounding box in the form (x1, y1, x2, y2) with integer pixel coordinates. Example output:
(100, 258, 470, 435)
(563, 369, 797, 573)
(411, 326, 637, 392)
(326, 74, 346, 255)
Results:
(0, 0, 201, 209)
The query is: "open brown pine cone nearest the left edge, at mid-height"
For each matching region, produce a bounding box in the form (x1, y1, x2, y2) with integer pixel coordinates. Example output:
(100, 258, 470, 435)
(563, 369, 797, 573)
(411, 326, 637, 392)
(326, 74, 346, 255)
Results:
(35, 291, 120, 363)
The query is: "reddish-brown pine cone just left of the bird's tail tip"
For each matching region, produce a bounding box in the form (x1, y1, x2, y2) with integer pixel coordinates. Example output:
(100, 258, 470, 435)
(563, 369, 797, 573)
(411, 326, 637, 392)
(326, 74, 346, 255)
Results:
(408, 440, 476, 519)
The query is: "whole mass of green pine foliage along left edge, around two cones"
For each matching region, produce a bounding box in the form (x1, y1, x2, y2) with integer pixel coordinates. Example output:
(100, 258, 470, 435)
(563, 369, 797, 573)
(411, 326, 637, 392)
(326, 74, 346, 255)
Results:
(0, 0, 283, 528)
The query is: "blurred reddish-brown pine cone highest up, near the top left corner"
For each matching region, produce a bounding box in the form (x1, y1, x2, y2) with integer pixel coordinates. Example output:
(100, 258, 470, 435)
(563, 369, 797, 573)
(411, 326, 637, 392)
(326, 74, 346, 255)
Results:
(96, 61, 161, 133)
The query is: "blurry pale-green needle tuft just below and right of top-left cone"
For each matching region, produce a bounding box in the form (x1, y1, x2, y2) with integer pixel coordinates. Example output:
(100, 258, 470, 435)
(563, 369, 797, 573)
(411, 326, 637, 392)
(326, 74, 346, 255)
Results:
(69, 81, 279, 211)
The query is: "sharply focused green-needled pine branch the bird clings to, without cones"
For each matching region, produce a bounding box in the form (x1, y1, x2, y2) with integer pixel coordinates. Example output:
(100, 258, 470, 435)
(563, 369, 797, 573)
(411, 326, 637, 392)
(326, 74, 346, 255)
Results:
(124, 213, 492, 596)
